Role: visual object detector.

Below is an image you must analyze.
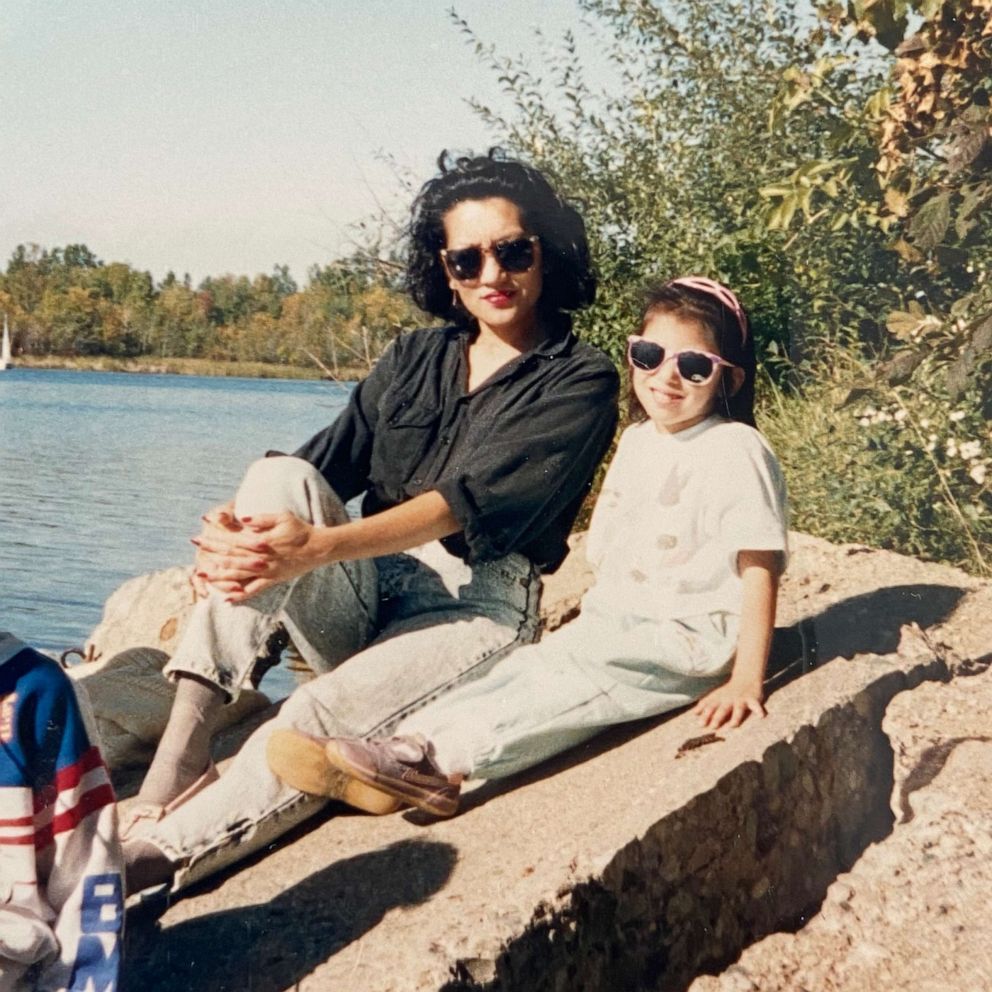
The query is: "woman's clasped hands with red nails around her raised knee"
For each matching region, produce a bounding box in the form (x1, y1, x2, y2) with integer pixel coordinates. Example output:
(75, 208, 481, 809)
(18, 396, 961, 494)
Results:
(201, 512, 330, 603)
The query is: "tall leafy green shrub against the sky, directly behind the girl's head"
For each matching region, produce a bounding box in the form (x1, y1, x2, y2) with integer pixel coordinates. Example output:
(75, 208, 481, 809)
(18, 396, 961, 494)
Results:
(457, 0, 896, 357)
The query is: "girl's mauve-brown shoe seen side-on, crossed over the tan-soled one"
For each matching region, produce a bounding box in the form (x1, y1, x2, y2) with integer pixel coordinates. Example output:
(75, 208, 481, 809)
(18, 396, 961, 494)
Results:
(324, 734, 461, 816)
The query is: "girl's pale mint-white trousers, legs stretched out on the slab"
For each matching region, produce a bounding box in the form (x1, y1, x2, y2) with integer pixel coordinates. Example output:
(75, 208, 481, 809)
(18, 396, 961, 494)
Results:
(397, 599, 740, 778)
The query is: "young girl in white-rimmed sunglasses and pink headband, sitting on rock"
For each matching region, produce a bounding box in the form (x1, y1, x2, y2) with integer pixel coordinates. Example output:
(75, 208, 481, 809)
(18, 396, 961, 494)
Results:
(268, 277, 787, 816)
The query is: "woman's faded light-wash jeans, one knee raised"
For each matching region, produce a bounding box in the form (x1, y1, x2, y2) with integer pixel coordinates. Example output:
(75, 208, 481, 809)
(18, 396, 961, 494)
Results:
(143, 457, 540, 889)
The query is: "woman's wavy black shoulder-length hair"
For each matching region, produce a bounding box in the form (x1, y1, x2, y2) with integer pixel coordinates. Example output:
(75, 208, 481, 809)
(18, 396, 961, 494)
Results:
(406, 148, 596, 326)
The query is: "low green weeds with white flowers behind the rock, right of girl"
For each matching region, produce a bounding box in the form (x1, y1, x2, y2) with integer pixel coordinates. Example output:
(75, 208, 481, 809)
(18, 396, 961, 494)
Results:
(758, 350, 992, 575)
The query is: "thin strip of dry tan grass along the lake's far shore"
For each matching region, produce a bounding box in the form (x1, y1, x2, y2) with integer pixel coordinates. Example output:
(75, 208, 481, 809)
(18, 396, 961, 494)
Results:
(12, 355, 368, 382)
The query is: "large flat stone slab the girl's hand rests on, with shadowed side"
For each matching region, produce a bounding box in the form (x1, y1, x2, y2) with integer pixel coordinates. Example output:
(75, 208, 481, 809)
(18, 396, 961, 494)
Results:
(118, 535, 992, 992)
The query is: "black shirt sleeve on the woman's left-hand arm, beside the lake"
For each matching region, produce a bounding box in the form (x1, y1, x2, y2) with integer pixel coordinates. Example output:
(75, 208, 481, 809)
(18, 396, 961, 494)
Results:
(293, 341, 397, 502)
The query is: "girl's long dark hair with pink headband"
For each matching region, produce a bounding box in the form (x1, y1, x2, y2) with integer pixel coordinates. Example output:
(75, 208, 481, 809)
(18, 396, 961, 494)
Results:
(627, 283, 756, 427)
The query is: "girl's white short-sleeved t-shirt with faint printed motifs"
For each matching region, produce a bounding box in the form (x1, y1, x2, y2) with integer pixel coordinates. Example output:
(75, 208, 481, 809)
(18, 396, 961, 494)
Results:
(584, 416, 788, 619)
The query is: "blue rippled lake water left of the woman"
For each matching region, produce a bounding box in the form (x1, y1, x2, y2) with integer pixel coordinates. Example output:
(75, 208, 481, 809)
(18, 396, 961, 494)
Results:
(0, 368, 351, 695)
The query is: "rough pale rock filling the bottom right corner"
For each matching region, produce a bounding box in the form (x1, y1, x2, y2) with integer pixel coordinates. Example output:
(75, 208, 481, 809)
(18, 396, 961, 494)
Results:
(691, 669, 992, 992)
